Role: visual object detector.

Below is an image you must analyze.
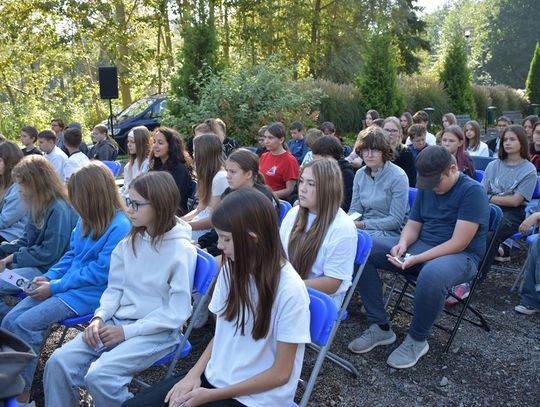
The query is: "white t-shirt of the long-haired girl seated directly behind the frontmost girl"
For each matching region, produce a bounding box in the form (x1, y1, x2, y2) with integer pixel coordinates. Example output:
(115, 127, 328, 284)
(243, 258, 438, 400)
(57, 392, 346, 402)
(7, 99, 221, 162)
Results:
(279, 206, 358, 309)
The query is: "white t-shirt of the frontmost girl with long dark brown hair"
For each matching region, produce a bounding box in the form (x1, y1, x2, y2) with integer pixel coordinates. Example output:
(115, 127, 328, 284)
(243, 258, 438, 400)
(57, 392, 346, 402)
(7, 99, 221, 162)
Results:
(205, 262, 311, 407)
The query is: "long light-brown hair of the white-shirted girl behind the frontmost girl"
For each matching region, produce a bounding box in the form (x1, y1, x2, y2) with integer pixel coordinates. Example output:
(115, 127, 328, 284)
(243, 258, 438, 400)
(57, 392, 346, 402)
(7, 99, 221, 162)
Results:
(287, 158, 343, 279)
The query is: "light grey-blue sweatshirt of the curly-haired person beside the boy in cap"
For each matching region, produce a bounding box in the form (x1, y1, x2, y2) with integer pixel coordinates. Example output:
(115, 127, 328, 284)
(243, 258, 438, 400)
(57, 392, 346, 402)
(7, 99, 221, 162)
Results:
(349, 161, 409, 232)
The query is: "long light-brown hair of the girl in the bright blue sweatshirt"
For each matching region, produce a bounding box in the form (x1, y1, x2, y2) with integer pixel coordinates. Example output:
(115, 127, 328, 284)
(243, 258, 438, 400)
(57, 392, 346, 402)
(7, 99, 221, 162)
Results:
(67, 161, 124, 240)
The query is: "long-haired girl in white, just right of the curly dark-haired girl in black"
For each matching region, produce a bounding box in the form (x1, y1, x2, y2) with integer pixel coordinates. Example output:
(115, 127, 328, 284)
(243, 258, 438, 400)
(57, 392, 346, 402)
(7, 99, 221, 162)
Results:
(183, 134, 228, 240)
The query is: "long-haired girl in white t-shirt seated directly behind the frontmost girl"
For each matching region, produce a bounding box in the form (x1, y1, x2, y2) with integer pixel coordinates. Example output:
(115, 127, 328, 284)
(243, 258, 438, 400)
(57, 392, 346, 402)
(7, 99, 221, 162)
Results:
(280, 158, 357, 308)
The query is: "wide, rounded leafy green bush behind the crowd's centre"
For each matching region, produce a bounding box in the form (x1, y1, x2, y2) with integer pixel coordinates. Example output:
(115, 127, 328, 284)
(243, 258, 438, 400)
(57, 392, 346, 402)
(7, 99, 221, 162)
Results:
(163, 61, 323, 145)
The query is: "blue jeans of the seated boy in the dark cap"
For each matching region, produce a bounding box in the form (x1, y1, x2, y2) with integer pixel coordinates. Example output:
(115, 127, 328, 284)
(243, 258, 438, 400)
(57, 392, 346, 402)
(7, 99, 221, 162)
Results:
(358, 237, 477, 341)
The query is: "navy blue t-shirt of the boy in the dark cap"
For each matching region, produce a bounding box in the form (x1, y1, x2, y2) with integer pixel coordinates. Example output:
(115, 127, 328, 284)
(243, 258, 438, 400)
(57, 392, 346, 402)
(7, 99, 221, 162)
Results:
(410, 173, 490, 261)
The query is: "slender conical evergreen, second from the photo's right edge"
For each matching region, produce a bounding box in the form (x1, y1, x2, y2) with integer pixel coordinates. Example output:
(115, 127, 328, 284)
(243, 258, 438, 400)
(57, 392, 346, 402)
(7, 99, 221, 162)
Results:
(439, 34, 474, 114)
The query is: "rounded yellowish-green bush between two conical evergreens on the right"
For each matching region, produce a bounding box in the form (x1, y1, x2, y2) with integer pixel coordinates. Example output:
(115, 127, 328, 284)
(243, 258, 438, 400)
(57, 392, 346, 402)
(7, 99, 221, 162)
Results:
(399, 75, 451, 123)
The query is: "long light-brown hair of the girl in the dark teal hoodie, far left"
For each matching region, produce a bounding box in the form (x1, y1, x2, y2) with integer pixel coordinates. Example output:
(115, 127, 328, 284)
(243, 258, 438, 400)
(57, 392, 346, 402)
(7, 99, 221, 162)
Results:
(12, 154, 68, 227)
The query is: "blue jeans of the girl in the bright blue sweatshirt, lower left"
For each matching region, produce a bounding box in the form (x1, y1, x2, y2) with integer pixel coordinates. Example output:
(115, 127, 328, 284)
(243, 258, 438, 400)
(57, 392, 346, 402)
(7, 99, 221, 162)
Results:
(2, 297, 77, 389)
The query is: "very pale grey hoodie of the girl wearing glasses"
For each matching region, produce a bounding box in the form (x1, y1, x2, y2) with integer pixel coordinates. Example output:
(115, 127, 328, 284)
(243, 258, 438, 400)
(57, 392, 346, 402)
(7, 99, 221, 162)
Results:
(95, 219, 197, 339)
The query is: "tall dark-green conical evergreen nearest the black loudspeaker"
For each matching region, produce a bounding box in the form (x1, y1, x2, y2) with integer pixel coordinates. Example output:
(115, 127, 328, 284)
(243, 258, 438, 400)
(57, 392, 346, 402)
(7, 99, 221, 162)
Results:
(171, 0, 220, 103)
